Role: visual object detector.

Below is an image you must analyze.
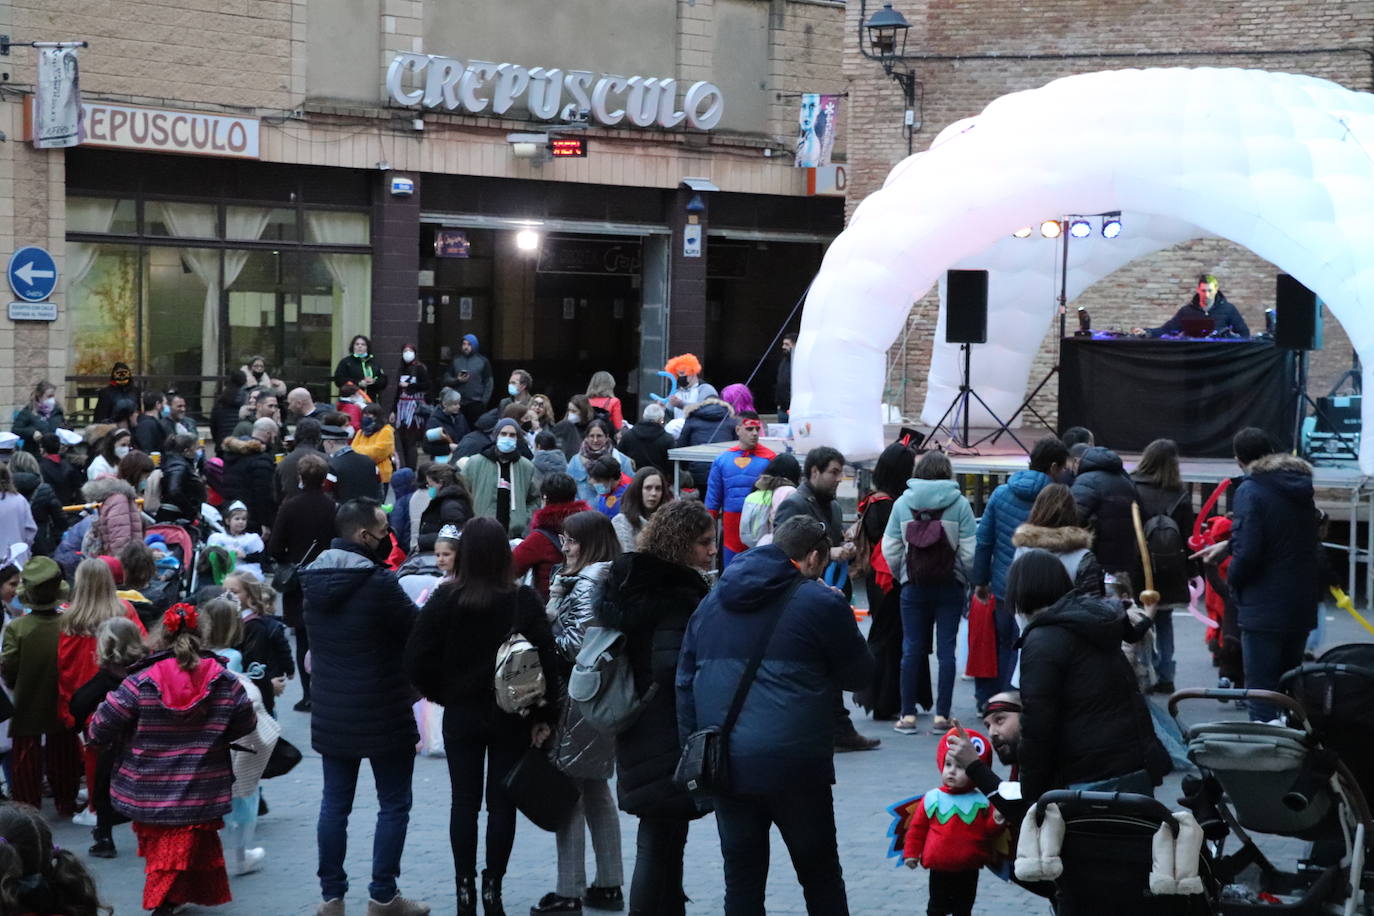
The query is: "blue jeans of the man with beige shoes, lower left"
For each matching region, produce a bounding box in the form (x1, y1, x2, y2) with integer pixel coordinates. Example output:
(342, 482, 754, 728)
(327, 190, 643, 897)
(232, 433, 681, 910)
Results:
(316, 748, 415, 904)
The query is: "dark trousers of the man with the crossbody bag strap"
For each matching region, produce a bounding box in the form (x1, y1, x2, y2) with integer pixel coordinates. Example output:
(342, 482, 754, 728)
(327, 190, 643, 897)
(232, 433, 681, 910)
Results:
(716, 786, 849, 916)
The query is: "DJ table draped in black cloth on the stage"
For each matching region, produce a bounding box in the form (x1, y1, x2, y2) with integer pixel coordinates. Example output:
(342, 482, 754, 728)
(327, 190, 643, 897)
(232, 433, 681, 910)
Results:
(1059, 338, 1297, 457)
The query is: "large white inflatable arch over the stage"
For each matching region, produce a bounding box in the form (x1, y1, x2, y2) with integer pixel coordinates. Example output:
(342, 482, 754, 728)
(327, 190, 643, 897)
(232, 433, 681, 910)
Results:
(791, 69, 1374, 474)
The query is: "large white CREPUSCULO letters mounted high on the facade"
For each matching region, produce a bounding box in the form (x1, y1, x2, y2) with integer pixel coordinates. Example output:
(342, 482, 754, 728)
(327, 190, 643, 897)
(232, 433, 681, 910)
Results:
(386, 54, 725, 130)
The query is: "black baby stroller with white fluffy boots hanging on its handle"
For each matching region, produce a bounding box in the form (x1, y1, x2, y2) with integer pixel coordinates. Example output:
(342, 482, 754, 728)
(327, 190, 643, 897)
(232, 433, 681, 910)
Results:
(1015, 790, 1216, 916)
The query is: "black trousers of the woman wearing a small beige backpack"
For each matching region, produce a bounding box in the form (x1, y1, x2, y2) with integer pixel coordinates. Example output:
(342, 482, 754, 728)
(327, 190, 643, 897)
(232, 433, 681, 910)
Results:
(444, 705, 529, 878)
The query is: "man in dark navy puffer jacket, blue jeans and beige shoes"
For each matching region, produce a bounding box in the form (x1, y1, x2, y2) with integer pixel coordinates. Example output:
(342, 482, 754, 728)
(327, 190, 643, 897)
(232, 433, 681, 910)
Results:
(300, 500, 430, 916)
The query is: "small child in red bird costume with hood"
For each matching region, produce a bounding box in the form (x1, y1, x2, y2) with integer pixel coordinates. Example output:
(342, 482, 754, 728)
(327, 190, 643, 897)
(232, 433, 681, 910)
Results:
(903, 729, 1007, 916)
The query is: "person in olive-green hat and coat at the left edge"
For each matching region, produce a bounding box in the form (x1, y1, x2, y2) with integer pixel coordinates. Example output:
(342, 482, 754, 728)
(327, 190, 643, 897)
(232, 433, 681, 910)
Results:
(0, 556, 81, 817)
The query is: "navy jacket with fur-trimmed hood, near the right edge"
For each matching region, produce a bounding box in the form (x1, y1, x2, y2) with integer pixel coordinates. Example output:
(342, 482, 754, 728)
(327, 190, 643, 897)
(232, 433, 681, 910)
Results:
(1227, 453, 1326, 633)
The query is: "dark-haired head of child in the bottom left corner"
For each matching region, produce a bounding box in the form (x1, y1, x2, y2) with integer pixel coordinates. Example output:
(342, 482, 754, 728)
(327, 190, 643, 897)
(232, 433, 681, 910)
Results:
(0, 802, 114, 916)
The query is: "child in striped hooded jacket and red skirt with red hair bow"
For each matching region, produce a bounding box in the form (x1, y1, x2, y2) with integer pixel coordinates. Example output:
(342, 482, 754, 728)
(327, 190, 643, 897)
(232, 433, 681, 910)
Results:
(87, 604, 257, 916)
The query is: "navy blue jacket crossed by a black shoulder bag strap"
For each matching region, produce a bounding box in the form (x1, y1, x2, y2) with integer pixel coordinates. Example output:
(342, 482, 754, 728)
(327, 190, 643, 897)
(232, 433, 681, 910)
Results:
(677, 544, 874, 795)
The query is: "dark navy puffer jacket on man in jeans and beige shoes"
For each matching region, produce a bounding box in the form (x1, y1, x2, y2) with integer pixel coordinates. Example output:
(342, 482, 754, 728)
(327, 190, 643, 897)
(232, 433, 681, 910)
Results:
(300, 538, 419, 758)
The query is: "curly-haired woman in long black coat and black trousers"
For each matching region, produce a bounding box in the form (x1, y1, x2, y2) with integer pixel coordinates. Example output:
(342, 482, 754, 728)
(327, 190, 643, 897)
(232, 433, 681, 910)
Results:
(600, 500, 716, 916)
